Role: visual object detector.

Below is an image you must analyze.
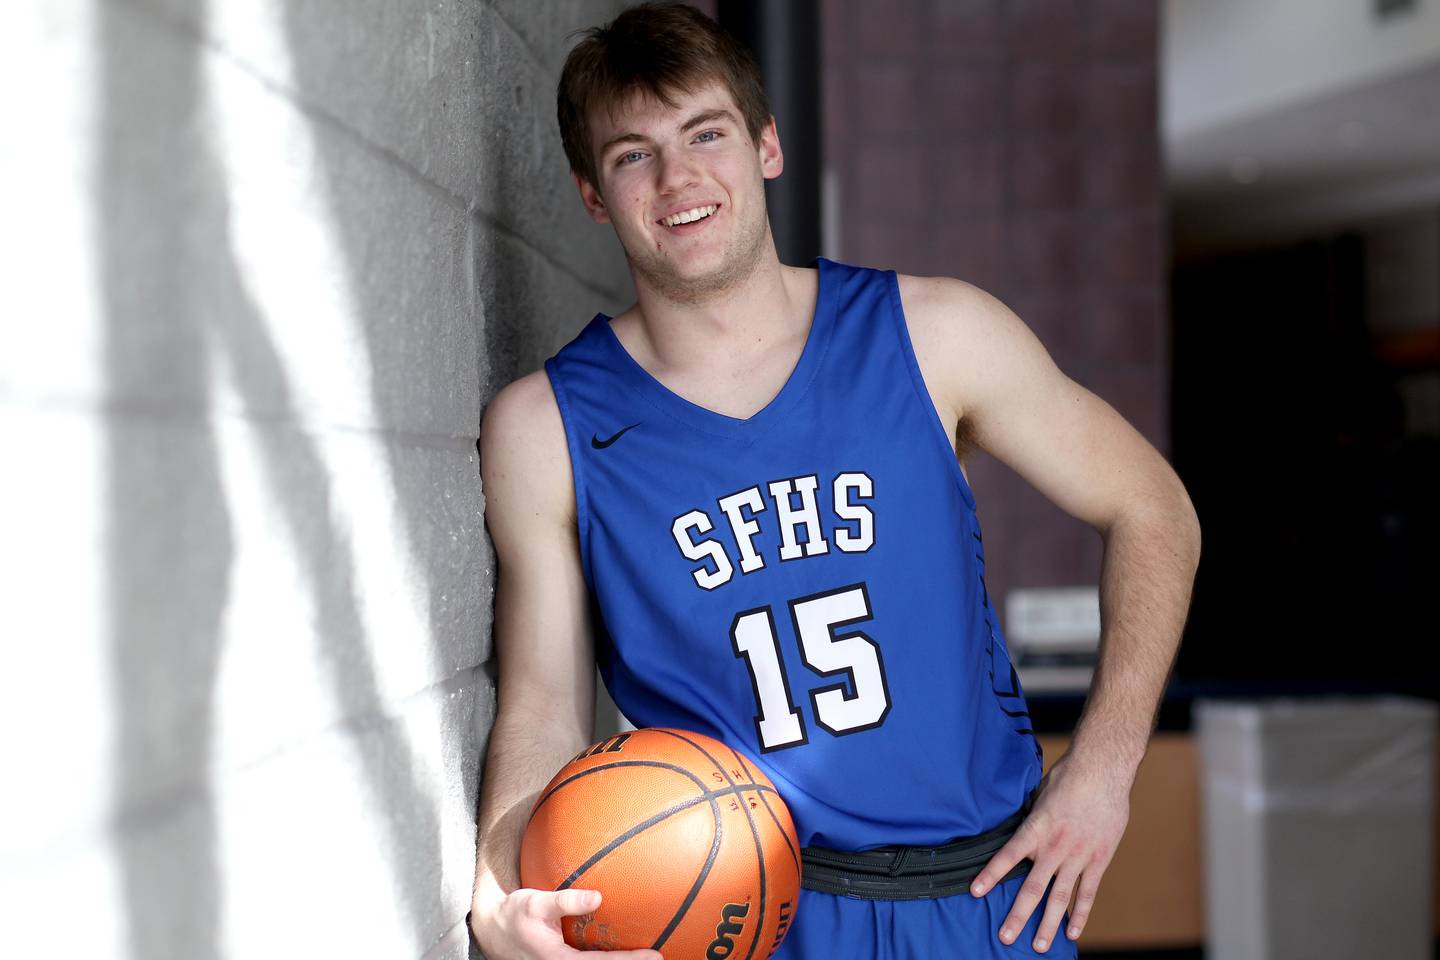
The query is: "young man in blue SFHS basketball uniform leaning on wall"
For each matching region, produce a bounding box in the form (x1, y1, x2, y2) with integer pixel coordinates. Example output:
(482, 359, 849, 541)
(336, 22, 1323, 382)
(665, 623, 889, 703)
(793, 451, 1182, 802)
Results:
(471, 4, 1200, 960)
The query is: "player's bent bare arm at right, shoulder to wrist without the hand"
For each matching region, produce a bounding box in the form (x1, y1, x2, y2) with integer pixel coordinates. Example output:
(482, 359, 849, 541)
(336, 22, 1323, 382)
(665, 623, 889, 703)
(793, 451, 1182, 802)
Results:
(906, 278, 1200, 786)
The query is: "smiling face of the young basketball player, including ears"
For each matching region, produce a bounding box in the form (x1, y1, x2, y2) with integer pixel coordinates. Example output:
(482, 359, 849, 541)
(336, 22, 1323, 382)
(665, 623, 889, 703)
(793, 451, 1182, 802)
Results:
(576, 81, 783, 302)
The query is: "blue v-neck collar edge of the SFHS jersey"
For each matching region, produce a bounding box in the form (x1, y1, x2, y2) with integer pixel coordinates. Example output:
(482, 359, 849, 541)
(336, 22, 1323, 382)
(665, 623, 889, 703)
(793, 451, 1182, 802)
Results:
(590, 256, 838, 438)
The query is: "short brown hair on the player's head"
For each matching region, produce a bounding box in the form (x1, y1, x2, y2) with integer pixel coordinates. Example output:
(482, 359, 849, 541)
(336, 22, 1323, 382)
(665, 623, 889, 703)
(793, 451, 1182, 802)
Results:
(554, 1, 770, 189)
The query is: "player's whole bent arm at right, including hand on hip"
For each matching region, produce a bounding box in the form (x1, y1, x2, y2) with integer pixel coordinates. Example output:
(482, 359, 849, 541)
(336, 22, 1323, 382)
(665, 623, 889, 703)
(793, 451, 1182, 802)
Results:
(901, 278, 1200, 951)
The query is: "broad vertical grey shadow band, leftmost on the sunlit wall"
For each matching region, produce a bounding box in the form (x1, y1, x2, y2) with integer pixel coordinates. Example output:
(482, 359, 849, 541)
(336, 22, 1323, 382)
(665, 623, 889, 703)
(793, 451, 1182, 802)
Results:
(92, 4, 235, 960)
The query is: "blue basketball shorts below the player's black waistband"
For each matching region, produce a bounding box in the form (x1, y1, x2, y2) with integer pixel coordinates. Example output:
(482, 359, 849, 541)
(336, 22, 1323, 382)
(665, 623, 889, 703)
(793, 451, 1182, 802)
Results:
(772, 874, 1079, 960)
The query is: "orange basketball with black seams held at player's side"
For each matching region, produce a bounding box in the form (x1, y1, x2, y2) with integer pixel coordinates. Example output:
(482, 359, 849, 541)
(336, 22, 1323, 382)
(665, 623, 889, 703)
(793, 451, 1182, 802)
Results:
(520, 727, 801, 960)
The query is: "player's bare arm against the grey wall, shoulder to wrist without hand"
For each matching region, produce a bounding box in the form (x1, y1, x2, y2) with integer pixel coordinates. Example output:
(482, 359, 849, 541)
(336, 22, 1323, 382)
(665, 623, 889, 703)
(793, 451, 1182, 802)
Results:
(472, 370, 595, 915)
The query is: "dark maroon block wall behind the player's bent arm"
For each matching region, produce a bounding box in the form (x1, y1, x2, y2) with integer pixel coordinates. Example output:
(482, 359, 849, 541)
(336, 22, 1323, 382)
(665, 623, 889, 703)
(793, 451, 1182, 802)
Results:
(823, 0, 1171, 604)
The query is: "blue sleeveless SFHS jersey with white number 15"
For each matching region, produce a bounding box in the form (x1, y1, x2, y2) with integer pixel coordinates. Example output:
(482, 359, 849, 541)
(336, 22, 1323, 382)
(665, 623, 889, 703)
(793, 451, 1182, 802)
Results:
(544, 258, 1041, 851)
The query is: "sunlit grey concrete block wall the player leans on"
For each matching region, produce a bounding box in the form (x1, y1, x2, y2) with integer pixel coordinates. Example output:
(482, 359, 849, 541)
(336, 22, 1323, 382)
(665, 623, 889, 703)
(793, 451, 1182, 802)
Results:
(0, 0, 632, 960)
